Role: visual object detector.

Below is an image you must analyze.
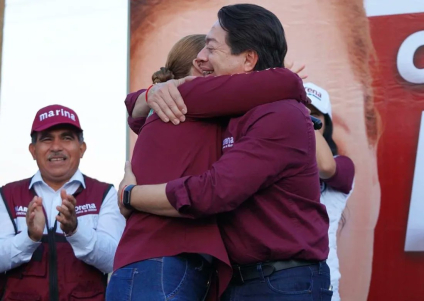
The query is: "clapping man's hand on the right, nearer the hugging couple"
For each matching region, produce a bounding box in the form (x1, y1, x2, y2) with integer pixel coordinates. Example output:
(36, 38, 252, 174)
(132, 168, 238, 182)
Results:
(56, 189, 78, 235)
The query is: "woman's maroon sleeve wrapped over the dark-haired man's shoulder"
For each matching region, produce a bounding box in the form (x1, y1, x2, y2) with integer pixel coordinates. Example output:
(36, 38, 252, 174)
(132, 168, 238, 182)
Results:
(179, 68, 309, 118)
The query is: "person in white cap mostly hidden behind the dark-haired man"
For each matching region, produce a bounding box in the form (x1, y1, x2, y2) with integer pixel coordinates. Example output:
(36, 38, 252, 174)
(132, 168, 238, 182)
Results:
(304, 83, 355, 301)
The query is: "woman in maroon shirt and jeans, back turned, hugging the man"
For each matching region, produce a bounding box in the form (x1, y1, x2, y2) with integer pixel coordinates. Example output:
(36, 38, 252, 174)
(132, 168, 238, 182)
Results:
(107, 35, 303, 300)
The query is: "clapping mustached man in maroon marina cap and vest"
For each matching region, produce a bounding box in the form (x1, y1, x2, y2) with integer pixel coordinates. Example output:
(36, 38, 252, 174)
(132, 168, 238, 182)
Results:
(0, 105, 125, 301)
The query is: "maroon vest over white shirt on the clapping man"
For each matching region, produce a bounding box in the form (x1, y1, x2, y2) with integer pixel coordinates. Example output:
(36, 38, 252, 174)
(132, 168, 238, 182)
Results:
(0, 176, 112, 301)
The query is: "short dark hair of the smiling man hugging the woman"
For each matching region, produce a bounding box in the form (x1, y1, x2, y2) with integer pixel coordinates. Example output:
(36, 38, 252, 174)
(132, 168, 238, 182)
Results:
(218, 4, 287, 70)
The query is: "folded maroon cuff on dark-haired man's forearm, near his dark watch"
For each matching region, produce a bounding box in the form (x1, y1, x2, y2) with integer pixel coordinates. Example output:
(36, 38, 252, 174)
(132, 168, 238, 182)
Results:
(165, 177, 195, 218)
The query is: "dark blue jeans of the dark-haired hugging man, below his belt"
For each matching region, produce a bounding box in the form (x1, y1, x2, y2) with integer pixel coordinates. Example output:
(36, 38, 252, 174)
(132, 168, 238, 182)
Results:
(221, 262, 333, 301)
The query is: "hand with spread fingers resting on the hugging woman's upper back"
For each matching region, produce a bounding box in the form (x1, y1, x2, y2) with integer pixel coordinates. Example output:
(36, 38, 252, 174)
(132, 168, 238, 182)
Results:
(147, 76, 196, 125)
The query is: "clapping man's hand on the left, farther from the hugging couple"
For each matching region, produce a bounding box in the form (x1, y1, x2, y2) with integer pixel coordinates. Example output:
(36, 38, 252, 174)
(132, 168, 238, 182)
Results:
(26, 196, 46, 241)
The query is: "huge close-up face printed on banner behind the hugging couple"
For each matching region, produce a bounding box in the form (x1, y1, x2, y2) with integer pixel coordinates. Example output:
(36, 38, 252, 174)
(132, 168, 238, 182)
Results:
(130, 0, 380, 301)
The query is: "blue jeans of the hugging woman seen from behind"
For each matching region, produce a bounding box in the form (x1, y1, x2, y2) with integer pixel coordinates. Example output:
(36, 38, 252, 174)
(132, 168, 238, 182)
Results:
(106, 254, 212, 301)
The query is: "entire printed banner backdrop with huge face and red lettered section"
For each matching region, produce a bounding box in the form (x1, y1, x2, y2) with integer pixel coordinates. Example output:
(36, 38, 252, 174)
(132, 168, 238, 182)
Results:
(130, 0, 424, 301)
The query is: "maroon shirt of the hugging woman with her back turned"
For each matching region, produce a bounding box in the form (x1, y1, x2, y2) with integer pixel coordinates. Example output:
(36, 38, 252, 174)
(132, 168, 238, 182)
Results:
(114, 68, 306, 292)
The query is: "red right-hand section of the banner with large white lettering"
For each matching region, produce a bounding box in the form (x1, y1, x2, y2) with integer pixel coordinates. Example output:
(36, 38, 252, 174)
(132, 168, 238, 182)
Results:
(368, 1, 424, 301)
